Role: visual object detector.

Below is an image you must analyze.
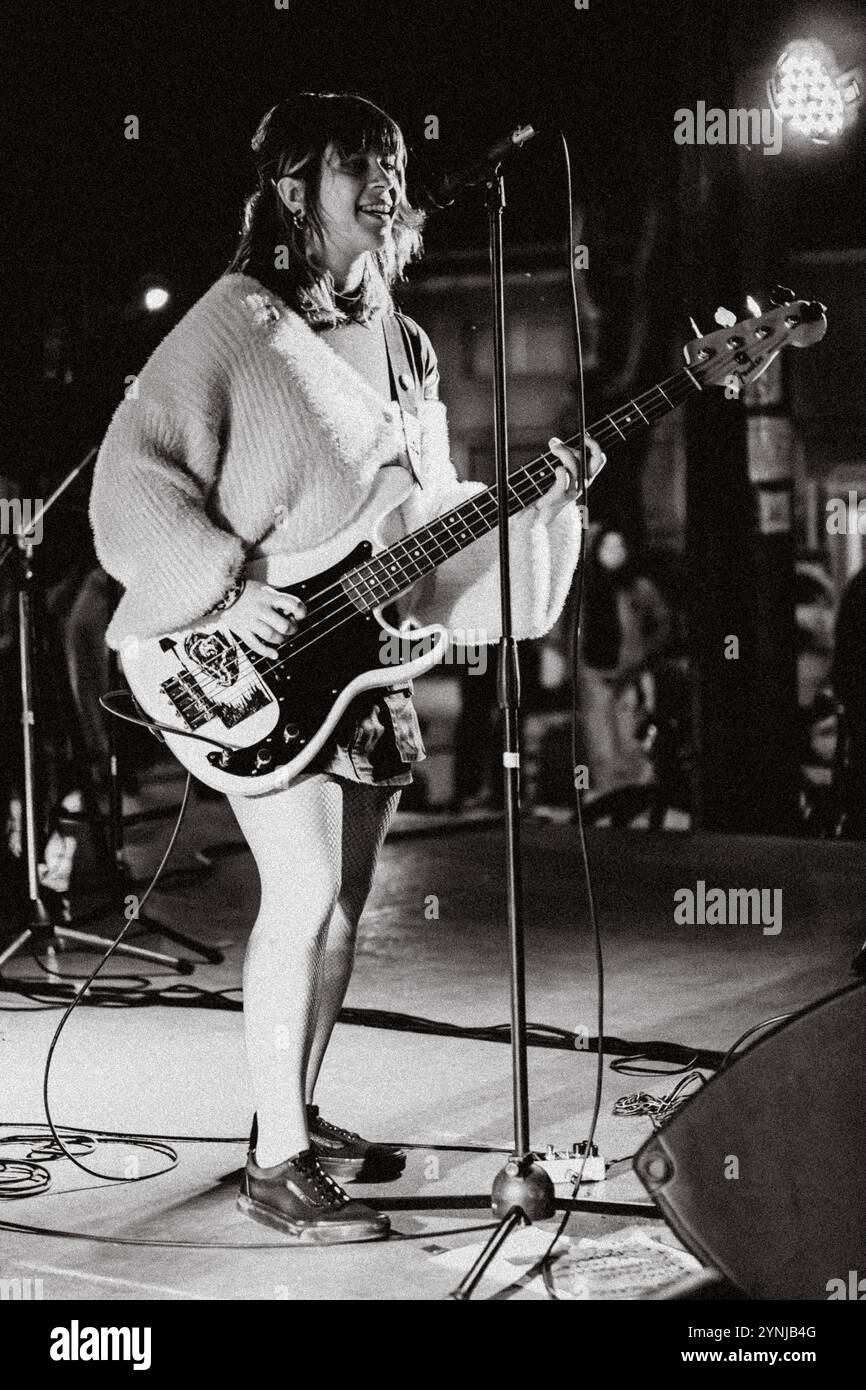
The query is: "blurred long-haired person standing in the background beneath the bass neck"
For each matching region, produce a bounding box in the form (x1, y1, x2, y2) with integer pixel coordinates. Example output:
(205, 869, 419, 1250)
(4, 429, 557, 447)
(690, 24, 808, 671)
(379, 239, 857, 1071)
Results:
(580, 525, 671, 795)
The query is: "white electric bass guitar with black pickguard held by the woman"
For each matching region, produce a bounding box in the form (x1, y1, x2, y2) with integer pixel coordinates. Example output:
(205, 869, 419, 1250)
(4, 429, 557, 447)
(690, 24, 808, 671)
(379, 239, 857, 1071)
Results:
(122, 297, 827, 796)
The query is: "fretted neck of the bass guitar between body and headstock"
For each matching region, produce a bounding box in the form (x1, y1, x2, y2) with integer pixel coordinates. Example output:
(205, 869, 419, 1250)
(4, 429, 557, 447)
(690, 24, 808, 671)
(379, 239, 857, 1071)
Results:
(342, 367, 702, 609)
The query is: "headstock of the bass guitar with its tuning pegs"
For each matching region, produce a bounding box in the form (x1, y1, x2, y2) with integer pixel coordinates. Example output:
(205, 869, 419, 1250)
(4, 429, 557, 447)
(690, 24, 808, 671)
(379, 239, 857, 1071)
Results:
(683, 292, 827, 386)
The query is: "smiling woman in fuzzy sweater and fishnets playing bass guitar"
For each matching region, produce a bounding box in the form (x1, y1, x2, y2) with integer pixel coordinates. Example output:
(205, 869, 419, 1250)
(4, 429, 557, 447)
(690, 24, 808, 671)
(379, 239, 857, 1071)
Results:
(92, 93, 601, 1243)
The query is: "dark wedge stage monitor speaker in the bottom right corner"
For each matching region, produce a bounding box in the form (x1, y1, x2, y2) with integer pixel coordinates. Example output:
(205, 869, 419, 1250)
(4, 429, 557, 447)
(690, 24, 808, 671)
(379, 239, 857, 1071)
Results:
(634, 984, 866, 1300)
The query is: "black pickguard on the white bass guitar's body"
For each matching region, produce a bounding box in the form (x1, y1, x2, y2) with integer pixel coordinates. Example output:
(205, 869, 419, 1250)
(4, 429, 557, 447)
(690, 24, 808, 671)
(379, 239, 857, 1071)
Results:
(207, 541, 396, 777)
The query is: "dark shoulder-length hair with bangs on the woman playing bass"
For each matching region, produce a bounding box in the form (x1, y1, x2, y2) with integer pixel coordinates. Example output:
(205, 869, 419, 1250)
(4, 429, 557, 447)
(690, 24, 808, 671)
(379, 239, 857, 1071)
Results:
(227, 92, 424, 328)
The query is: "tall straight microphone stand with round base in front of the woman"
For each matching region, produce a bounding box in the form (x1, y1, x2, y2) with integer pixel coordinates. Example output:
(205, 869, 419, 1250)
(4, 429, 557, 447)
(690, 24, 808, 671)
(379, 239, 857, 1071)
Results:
(449, 164, 556, 1300)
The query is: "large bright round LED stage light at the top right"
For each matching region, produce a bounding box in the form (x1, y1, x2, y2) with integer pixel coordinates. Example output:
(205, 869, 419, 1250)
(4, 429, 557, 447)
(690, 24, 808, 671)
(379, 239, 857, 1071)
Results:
(767, 39, 863, 145)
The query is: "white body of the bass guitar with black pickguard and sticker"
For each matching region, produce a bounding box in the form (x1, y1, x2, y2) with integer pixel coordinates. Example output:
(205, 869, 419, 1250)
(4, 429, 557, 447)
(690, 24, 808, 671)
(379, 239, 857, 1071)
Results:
(122, 468, 449, 796)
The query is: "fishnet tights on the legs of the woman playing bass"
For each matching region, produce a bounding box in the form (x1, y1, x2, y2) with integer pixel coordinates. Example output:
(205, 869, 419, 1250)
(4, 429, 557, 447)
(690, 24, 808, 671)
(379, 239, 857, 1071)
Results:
(229, 773, 400, 1168)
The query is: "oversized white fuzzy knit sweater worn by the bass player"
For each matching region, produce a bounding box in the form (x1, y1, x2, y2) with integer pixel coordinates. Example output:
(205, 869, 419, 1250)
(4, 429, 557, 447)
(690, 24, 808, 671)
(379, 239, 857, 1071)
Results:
(90, 274, 580, 649)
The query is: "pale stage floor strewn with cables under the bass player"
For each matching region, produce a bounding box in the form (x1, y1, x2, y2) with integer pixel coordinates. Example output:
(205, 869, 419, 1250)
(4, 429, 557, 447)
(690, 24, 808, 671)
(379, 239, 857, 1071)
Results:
(0, 784, 866, 1300)
